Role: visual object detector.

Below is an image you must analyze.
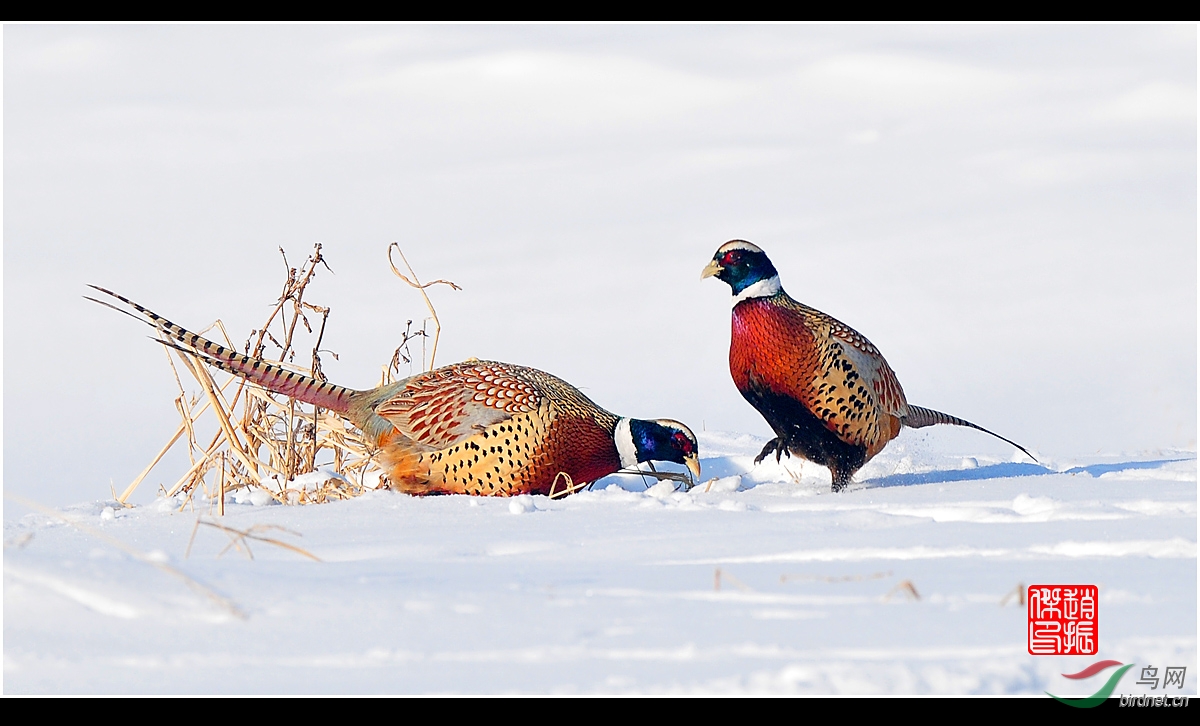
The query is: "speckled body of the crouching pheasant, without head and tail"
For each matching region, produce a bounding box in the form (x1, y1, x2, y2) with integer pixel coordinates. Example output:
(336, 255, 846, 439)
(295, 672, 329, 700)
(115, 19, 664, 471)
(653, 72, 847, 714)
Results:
(373, 361, 620, 496)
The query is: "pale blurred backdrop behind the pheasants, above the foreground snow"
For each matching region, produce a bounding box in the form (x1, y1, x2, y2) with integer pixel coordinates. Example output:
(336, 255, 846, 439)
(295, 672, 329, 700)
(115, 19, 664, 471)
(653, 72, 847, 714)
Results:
(4, 25, 1196, 504)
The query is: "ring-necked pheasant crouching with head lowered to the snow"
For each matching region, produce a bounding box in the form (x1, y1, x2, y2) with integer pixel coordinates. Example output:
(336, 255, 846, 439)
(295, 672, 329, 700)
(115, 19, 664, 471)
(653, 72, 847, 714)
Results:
(89, 286, 700, 497)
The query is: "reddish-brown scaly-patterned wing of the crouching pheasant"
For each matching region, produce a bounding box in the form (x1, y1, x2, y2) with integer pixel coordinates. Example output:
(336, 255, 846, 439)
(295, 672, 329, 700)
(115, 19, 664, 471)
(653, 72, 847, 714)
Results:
(374, 361, 541, 449)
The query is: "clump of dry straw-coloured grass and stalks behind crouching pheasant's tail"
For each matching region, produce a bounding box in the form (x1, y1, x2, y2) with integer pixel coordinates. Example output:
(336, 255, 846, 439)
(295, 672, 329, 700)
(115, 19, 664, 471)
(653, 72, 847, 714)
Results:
(116, 245, 457, 508)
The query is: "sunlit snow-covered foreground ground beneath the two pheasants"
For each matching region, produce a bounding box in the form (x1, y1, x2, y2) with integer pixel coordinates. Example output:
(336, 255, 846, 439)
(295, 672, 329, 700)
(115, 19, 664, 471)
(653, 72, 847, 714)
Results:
(4, 427, 1196, 695)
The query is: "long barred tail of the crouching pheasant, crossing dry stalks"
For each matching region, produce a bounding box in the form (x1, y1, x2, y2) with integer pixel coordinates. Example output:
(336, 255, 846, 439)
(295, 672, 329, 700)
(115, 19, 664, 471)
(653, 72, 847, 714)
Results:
(88, 284, 358, 415)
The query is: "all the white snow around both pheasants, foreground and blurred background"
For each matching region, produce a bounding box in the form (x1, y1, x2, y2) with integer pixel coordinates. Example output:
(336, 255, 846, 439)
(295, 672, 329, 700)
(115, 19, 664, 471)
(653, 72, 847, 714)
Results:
(0, 24, 1198, 698)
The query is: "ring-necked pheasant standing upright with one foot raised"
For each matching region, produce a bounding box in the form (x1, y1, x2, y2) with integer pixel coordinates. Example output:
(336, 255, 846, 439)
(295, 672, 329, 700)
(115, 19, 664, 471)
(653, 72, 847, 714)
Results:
(701, 240, 1037, 492)
